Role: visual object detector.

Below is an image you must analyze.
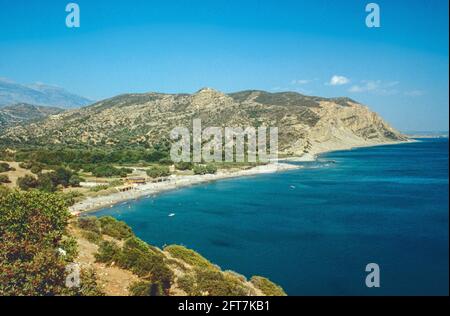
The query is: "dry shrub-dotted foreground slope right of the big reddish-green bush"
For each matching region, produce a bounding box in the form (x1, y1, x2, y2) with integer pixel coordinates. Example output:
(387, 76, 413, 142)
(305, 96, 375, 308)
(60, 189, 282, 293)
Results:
(69, 217, 286, 296)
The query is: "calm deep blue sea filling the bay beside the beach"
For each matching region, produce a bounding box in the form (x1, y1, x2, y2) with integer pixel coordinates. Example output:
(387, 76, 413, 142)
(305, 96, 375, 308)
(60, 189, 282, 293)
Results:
(96, 140, 449, 295)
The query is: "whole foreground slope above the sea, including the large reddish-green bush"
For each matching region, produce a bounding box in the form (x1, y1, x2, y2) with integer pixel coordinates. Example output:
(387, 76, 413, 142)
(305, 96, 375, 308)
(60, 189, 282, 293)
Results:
(0, 186, 286, 296)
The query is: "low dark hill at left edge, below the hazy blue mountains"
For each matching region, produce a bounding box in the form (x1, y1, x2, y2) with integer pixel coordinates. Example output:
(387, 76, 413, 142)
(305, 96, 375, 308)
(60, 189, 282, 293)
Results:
(0, 103, 63, 131)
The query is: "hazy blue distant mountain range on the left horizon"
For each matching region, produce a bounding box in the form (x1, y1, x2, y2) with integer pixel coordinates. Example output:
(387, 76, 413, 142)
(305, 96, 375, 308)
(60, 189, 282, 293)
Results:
(0, 78, 93, 109)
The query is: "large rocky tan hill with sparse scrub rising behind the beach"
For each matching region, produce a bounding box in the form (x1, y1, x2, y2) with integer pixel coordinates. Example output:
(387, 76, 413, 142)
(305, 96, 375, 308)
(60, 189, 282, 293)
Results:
(0, 88, 407, 156)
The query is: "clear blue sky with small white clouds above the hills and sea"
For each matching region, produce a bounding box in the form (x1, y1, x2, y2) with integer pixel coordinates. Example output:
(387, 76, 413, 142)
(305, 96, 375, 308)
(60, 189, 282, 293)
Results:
(0, 0, 449, 130)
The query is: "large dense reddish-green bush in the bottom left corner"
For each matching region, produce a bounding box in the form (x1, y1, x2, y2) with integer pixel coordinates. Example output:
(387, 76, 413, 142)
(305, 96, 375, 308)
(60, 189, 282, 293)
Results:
(0, 191, 102, 296)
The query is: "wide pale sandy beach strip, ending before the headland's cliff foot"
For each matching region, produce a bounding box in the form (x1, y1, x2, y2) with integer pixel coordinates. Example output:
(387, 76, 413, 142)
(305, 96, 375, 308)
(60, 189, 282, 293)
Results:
(69, 163, 301, 216)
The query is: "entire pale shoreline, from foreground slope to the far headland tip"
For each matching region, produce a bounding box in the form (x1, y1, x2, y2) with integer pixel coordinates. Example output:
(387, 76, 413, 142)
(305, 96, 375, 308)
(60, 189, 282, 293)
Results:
(69, 139, 417, 216)
